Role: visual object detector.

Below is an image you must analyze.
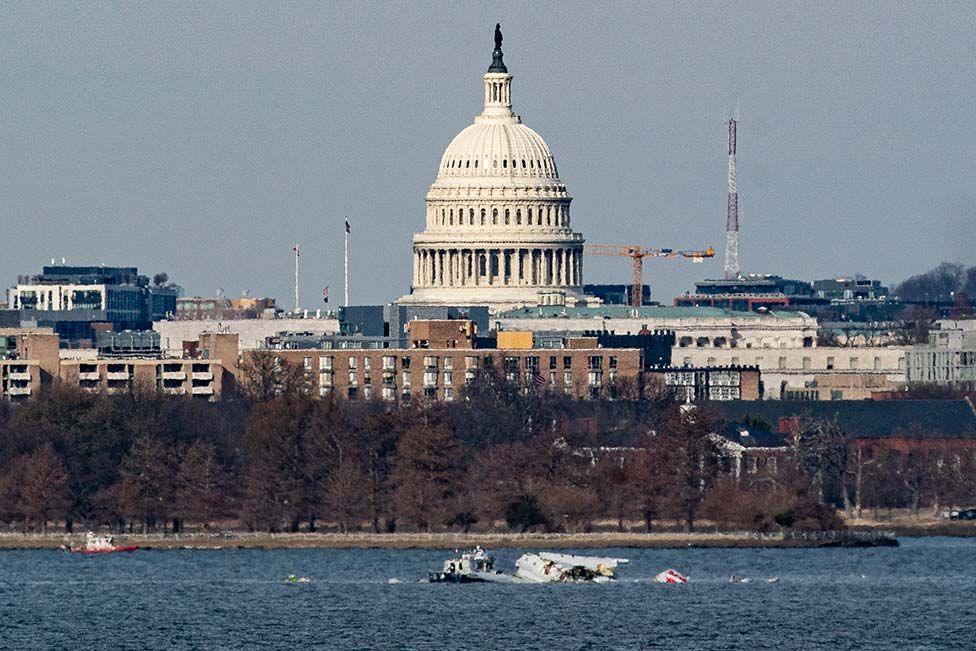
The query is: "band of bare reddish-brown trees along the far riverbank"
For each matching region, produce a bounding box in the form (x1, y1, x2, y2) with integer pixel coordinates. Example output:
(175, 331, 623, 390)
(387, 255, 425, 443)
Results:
(0, 362, 976, 532)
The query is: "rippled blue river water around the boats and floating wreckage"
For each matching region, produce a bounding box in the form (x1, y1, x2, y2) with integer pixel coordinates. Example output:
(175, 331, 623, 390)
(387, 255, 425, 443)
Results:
(0, 538, 976, 651)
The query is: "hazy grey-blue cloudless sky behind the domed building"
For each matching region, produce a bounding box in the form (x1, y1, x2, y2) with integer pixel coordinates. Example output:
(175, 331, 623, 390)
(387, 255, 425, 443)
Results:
(0, 2, 976, 307)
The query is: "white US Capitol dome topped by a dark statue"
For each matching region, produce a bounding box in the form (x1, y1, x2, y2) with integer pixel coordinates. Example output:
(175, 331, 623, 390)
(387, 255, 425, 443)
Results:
(401, 26, 596, 311)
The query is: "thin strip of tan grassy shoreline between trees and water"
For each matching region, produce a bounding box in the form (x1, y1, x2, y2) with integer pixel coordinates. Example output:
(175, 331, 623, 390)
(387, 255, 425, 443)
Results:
(0, 532, 916, 549)
